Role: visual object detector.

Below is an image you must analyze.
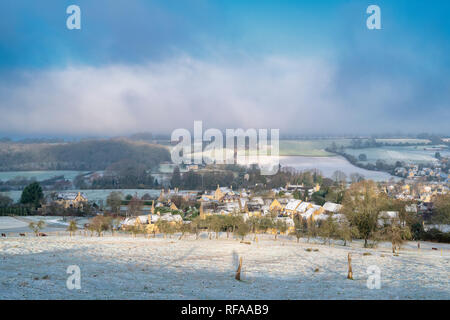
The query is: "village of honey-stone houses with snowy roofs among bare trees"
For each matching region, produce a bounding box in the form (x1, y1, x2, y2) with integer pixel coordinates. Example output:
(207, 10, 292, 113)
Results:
(23, 169, 450, 246)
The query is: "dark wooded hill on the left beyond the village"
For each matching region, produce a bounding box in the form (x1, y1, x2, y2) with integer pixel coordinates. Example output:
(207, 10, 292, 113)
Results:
(0, 139, 170, 171)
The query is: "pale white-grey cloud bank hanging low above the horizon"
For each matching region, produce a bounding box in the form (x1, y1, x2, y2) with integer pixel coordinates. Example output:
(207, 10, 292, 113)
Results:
(0, 56, 450, 136)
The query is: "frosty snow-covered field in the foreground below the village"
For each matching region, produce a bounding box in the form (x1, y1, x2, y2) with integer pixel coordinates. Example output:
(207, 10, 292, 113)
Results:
(0, 235, 450, 299)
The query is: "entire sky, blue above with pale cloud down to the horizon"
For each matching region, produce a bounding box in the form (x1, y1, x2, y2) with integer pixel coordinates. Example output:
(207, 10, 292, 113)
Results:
(0, 0, 450, 137)
